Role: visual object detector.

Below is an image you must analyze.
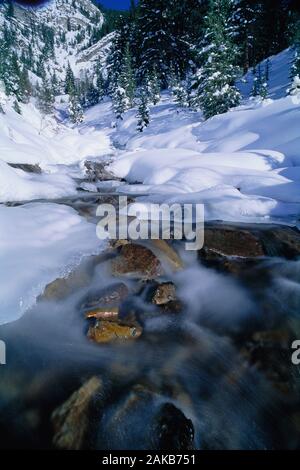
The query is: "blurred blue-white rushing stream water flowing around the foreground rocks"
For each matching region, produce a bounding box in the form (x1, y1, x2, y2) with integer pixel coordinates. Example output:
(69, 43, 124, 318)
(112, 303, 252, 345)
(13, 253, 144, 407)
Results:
(0, 189, 300, 449)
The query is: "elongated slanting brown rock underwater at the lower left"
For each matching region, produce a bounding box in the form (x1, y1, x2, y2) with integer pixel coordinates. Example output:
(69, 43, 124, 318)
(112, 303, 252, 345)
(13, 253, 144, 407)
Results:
(51, 377, 103, 450)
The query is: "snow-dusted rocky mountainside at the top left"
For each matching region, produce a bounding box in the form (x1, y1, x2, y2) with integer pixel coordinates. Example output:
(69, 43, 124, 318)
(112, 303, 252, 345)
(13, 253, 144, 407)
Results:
(0, 0, 110, 83)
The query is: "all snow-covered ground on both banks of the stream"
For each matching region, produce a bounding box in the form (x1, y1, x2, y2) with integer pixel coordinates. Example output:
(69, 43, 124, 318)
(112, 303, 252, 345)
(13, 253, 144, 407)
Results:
(0, 50, 300, 323)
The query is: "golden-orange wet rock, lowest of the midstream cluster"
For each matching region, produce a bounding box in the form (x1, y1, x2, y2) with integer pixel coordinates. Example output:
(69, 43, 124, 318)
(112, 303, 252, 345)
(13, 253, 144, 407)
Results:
(88, 320, 142, 344)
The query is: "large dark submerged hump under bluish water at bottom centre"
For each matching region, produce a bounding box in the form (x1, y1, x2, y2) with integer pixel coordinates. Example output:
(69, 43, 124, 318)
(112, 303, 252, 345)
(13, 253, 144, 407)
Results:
(96, 385, 194, 451)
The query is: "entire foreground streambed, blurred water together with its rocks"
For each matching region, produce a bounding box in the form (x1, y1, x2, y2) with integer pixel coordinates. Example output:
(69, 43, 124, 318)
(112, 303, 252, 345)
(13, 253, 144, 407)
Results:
(0, 167, 300, 451)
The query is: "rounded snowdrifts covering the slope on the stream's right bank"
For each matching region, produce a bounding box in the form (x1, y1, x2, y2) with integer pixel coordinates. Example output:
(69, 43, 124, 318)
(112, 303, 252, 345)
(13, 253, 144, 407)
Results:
(110, 50, 300, 223)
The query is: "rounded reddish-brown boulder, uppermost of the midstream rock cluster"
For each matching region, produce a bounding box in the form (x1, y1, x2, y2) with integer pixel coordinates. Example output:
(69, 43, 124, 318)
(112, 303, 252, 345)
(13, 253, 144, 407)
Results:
(112, 243, 162, 279)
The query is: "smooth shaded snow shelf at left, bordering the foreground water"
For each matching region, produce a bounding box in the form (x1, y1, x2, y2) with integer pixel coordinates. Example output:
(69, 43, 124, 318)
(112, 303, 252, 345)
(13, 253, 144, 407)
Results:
(0, 203, 103, 324)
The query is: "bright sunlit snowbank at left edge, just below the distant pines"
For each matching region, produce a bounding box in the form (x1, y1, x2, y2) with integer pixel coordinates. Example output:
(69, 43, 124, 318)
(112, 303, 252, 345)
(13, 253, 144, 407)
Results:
(0, 103, 111, 168)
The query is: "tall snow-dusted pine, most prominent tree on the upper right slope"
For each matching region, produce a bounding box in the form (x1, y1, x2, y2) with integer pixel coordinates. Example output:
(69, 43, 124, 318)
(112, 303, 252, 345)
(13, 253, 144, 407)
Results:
(195, 0, 241, 119)
